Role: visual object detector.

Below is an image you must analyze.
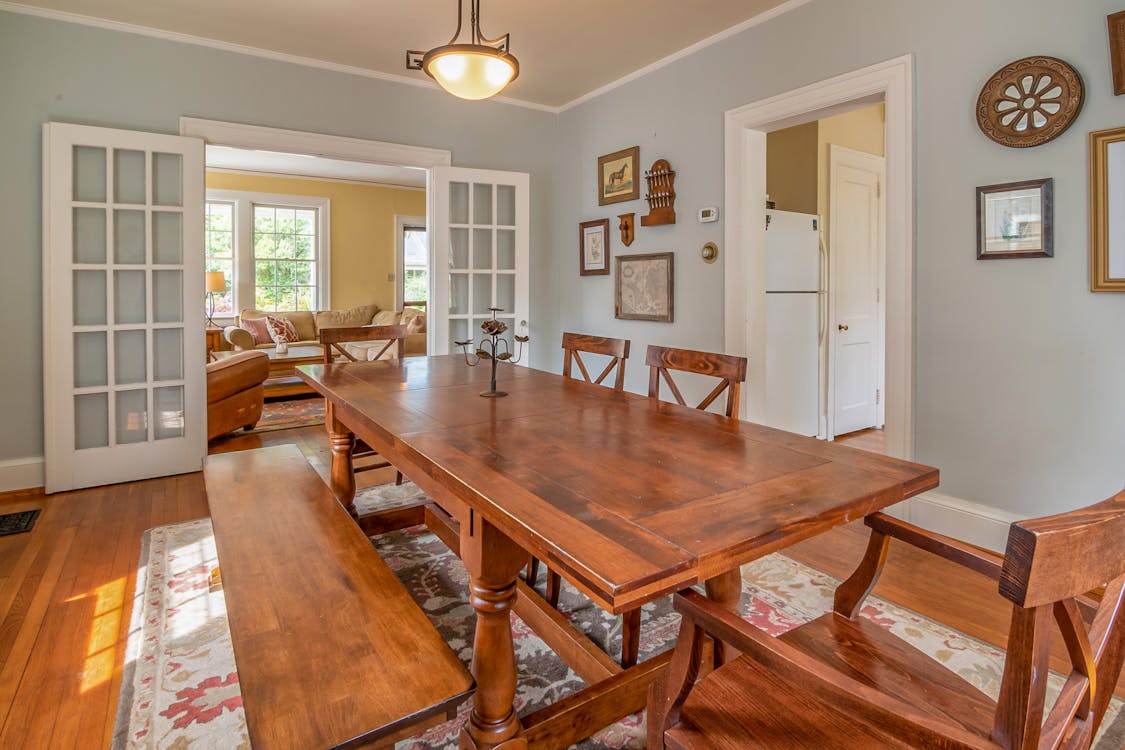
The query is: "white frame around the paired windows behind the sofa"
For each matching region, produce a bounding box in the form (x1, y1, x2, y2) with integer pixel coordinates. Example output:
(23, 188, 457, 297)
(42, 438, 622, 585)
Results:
(206, 189, 332, 315)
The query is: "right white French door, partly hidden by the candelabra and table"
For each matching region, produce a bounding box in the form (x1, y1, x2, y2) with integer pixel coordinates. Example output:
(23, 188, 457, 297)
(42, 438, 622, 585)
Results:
(428, 166, 530, 364)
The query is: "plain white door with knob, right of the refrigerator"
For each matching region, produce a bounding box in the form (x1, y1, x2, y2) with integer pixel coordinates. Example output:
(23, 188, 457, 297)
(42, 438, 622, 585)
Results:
(828, 145, 885, 436)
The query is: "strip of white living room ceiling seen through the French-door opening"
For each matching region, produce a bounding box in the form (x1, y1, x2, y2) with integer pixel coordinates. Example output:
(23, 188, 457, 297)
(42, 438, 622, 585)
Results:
(207, 146, 425, 188)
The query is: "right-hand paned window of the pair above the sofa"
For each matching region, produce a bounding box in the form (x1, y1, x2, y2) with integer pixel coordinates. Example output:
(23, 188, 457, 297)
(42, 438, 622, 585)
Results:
(253, 204, 318, 310)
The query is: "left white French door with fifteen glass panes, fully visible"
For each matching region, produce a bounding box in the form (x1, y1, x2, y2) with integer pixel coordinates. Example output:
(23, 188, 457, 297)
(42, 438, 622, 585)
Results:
(43, 123, 207, 493)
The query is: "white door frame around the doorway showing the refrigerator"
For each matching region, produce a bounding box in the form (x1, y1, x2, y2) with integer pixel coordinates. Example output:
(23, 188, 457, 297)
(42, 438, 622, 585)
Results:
(723, 55, 915, 459)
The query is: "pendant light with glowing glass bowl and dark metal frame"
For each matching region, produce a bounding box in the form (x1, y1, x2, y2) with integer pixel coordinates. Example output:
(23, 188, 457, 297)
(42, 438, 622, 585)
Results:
(406, 0, 520, 99)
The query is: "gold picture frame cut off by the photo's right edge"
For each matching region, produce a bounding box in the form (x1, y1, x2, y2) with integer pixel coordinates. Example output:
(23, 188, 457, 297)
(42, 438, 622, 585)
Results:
(1090, 127, 1125, 291)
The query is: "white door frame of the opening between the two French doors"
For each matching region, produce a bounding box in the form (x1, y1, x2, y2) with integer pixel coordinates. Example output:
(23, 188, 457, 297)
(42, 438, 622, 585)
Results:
(180, 117, 453, 353)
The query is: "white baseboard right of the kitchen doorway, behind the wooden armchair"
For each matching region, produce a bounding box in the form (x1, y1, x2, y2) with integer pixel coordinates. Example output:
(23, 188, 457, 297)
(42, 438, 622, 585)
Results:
(888, 493, 1022, 552)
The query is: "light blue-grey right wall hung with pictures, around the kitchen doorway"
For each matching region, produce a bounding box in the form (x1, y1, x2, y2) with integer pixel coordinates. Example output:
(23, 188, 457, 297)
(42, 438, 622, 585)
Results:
(556, 0, 1125, 515)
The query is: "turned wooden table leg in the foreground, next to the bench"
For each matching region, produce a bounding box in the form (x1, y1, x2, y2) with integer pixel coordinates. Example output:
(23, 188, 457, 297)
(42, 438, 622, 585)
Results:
(460, 510, 528, 750)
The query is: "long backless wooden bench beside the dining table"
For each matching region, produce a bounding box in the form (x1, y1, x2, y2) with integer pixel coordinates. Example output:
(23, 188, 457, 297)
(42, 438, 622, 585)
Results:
(204, 445, 474, 750)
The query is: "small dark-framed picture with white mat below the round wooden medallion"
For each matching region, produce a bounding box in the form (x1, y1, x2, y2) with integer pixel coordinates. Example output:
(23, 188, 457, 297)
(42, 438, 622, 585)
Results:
(977, 178, 1054, 260)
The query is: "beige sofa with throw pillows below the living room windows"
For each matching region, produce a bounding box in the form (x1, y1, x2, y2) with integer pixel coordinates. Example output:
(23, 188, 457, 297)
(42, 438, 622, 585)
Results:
(223, 305, 426, 360)
